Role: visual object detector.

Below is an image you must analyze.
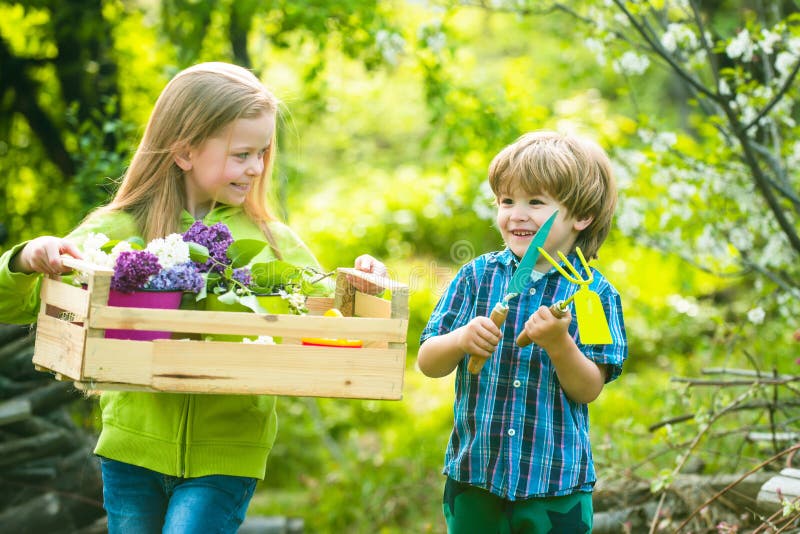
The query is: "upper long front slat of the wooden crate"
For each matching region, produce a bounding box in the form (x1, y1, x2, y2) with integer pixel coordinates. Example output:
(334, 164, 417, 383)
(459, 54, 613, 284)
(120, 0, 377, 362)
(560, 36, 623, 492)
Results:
(89, 306, 408, 342)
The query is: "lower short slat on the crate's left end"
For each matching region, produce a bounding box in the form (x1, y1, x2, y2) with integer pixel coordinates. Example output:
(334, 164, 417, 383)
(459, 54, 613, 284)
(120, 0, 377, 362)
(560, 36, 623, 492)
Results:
(33, 315, 86, 380)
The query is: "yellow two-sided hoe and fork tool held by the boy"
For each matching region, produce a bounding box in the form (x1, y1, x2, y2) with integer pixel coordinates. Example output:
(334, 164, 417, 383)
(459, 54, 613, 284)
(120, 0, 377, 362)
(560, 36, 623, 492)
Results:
(517, 247, 611, 347)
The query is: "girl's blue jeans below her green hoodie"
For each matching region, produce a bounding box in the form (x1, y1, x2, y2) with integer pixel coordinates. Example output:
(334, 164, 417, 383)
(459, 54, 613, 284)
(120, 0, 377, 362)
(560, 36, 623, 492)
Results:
(100, 457, 256, 534)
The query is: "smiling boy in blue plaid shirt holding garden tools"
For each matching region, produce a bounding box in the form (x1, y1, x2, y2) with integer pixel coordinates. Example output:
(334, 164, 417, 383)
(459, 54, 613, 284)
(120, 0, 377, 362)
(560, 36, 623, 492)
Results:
(418, 132, 628, 534)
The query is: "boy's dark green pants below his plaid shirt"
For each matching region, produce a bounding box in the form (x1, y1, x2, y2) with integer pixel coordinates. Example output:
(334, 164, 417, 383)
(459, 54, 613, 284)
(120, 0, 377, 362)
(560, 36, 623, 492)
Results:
(442, 477, 593, 534)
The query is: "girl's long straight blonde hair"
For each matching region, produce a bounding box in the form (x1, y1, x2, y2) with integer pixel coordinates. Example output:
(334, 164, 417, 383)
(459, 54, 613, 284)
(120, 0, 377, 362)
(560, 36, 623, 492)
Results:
(101, 62, 278, 240)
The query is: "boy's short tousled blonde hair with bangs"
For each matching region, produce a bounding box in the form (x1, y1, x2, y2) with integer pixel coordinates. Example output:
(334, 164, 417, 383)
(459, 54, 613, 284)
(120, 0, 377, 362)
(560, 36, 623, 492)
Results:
(489, 131, 617, 258)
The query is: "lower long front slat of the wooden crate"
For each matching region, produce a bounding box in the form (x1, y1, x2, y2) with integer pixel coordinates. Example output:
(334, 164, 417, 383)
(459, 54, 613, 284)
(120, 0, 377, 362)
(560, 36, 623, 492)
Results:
(84, 339, 406, 400)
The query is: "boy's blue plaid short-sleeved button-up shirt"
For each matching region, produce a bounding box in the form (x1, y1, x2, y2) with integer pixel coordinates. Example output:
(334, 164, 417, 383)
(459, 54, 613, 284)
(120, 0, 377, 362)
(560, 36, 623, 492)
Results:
(421, 249, 628, 501)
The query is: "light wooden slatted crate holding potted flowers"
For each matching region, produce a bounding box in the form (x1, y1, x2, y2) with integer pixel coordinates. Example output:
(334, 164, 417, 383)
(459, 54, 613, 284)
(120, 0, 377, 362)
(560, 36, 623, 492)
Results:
(33, 258, 408, 400)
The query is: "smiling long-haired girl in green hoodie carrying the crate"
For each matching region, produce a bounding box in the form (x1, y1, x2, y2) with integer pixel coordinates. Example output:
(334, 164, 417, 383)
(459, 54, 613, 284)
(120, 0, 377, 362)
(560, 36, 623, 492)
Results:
(0, 63, 385, 533)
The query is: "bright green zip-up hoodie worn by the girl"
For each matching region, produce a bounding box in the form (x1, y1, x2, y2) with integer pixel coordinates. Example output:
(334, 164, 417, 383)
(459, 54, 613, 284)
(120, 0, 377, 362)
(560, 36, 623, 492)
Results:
(0, 206, 332, 479)
